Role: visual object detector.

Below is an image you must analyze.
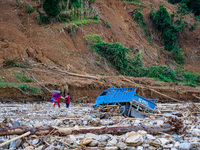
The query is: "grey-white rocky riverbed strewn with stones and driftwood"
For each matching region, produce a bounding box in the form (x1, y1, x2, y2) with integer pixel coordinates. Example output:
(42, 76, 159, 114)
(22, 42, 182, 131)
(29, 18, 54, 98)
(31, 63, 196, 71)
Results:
(0, 102, 200, 150)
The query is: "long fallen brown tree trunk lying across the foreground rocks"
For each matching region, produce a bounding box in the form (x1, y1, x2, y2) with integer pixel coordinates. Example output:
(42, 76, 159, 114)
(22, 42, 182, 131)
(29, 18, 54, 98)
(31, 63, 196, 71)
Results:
(0, 123, 173, 136)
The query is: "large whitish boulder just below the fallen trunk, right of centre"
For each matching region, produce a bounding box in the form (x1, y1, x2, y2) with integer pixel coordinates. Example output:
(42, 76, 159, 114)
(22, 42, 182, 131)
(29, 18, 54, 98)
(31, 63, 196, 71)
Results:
(125, 131, 143, 146)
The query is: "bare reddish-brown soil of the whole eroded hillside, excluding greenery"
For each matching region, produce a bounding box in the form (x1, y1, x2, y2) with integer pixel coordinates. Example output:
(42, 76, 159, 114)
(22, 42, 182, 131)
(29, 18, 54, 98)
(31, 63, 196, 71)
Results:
(0, 0, 200, 102)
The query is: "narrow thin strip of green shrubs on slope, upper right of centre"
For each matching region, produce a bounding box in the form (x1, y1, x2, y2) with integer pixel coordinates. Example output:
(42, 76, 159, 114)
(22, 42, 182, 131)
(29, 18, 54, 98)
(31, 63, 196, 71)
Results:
(132, 8, 153, 45)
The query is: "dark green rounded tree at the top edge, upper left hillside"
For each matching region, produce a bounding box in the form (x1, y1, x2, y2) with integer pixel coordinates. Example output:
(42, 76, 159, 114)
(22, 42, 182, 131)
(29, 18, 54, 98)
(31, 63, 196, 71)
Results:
(43, 0, 60, 18)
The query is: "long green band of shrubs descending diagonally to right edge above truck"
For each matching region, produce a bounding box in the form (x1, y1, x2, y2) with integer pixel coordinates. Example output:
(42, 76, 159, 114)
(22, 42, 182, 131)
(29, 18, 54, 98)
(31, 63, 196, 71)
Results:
(84, 34, 200, 87)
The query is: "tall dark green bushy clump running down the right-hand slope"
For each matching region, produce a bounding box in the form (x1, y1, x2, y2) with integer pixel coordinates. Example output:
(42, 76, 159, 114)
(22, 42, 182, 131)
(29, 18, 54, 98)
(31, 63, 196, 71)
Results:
(150, 5, 184, 65)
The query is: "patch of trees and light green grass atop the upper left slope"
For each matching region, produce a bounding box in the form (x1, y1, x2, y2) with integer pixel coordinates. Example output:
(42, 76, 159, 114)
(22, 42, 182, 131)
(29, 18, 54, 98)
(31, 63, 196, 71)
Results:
(37, 0, 97, 25)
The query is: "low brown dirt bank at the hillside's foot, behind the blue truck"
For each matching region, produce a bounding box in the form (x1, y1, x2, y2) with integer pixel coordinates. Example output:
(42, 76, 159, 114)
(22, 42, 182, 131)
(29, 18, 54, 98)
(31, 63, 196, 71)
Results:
(0, 68, 200, 103)
